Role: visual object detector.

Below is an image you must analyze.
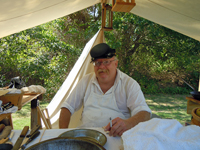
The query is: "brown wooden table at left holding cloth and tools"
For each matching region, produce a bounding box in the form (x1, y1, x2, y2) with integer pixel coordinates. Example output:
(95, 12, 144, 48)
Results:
(0, 90, 42, 128)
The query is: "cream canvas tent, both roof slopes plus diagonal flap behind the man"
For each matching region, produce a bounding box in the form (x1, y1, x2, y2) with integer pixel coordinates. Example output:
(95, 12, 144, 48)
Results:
(0, 0, 200, 128)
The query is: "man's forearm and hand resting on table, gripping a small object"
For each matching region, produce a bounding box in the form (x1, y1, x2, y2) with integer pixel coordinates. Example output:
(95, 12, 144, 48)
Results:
(105, 111, 151, 136)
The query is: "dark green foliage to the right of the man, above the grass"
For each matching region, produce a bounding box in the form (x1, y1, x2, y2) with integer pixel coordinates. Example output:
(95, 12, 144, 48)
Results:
(105, 12, 200, 94)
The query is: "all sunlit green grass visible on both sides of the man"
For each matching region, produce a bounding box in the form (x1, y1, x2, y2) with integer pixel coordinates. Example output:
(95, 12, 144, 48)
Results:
(12, 94, 191, 130)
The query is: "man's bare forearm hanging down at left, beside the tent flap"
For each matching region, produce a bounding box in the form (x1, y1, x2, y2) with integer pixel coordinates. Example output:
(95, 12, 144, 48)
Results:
(59, 107, 71, 129)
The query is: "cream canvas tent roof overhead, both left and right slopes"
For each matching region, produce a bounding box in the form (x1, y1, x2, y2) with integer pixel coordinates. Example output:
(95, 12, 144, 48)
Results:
(0, 0, 200, 41)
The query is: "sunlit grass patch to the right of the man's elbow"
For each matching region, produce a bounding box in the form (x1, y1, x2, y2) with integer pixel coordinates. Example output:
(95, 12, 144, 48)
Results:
(145, 95, 191, 124)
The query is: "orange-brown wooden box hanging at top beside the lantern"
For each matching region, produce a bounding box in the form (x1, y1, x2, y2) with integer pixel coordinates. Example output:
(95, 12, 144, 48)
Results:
(112, 0, 136, 12)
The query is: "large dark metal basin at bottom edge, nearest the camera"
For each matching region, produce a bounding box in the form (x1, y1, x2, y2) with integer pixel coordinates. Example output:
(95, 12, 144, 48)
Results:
(26, 138, 106, 150)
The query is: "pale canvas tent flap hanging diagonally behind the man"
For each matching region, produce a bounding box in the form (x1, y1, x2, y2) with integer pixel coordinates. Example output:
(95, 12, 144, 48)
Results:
(47, 30, 105, 128)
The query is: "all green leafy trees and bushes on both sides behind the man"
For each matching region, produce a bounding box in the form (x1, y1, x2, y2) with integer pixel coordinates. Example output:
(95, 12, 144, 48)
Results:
(0, 4, 200, 99)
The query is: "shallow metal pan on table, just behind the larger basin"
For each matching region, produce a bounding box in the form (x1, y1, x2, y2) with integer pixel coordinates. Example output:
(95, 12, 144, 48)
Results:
(59, 129, 107, 146)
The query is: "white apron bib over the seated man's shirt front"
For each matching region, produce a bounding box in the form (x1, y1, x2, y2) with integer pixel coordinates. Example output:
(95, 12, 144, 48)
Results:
(81, 82, 126, 127)
